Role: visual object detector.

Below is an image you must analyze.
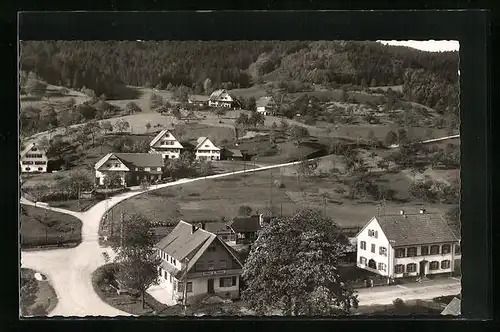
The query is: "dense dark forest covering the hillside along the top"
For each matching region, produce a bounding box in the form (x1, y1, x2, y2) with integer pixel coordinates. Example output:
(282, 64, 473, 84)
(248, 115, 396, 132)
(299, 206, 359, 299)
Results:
(20, 41, 458, 108)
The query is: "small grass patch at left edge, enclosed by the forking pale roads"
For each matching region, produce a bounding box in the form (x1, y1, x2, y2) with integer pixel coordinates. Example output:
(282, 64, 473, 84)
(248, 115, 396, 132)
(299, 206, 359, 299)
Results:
(20, 205, 82, 248)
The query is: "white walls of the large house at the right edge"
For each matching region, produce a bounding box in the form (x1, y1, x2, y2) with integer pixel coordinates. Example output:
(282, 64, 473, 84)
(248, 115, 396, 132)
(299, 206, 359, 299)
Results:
(357, 218, 460, 278)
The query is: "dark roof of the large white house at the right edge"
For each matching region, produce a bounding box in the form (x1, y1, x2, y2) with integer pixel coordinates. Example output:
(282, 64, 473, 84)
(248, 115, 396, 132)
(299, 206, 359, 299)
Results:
(376, 213, 458, 246)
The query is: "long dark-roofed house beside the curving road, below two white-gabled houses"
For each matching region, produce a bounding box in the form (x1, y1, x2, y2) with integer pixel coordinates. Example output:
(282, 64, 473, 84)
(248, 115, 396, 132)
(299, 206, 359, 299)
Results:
(94, 153, 164, 187)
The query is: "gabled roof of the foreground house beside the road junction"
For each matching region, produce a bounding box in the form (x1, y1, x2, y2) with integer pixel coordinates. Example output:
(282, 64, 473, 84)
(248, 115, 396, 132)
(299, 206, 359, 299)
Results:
(155, 220, 243, 273)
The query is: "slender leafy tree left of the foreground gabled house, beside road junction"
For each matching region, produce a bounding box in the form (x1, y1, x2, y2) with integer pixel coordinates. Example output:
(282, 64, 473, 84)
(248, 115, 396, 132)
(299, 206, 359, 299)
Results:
(113, 214, 161, 308)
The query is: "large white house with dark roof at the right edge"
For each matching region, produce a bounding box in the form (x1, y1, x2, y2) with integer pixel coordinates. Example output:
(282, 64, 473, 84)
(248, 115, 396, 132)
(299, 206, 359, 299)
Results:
(357, 209, 461, 279)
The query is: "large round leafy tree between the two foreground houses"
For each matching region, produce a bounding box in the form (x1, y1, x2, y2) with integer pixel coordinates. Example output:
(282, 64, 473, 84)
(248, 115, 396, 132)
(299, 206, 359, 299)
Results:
(242, 210, 358, 316)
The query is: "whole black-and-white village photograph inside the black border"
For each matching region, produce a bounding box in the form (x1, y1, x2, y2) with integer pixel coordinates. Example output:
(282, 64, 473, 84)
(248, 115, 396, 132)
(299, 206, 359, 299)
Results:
(18, 40, 465, 318)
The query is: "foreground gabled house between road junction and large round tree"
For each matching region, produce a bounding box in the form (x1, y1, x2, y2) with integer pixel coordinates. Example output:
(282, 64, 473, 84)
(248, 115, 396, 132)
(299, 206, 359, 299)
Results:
(155, 220, 243, 303)
